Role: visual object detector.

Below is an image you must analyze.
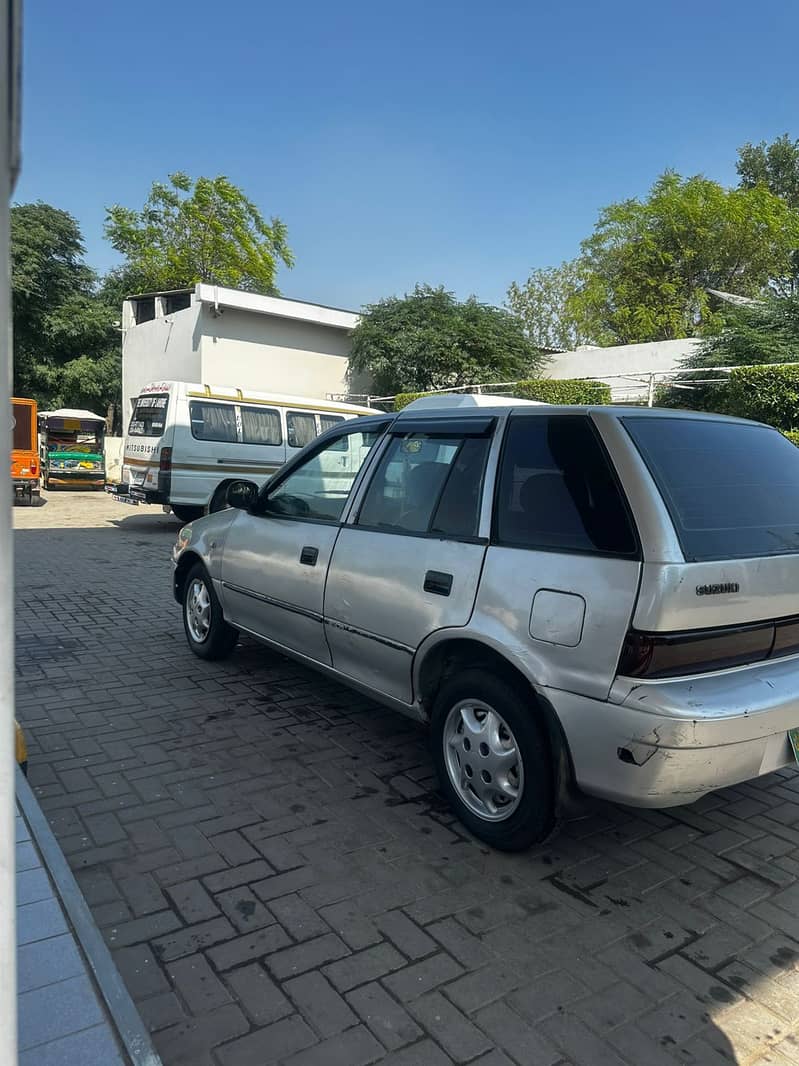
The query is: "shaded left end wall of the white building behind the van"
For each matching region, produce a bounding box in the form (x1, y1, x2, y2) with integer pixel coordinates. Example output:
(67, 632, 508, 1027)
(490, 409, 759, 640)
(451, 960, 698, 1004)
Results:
(123, 304, 201, 415)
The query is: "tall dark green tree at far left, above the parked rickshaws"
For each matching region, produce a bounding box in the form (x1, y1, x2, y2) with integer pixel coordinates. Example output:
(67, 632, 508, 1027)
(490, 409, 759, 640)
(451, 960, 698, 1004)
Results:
(11, 201, 119, 414)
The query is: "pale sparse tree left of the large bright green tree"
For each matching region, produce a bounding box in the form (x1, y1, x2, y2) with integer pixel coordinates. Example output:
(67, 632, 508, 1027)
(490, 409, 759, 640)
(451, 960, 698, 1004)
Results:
(507, 262, 590, 351)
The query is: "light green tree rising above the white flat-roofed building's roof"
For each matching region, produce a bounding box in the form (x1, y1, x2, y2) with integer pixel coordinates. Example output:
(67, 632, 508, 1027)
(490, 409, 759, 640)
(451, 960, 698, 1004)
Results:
(105, 172, 294, 295)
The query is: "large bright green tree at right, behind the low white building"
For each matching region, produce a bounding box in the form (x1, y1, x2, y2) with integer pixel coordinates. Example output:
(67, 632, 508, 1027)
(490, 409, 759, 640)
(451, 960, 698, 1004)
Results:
(571, 172, 799, 344)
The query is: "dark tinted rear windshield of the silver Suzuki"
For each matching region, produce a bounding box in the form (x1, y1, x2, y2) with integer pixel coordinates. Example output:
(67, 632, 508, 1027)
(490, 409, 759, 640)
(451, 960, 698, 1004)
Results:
(623, 418, 799, 562)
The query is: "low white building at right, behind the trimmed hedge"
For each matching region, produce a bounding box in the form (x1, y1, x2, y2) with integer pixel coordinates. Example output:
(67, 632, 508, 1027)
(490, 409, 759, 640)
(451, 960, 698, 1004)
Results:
(544, 337, 699, 402)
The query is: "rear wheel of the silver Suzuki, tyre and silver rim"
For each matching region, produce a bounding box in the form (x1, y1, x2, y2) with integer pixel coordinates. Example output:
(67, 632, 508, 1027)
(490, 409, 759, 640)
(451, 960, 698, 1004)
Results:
(430, 669, 555, 852)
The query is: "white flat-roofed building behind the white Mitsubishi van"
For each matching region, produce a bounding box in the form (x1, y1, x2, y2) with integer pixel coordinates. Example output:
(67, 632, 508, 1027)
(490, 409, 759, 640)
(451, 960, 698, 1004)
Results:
(123, 284, 363, 424)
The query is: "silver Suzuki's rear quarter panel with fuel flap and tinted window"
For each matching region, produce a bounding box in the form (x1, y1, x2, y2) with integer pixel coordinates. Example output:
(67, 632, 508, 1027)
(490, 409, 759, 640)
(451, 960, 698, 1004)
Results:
(476, 408, 640, 698)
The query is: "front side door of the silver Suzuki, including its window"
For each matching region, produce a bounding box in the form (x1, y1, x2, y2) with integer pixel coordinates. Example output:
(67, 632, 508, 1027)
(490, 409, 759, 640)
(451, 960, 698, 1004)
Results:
(222, 421, 384, 664)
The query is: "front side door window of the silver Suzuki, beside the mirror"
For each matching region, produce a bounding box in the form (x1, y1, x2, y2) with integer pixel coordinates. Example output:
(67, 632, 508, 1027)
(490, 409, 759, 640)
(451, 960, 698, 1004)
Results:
(264, 426, 384, 521)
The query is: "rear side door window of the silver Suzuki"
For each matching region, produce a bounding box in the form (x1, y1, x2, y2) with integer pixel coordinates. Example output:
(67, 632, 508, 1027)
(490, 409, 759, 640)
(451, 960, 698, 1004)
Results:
(358, 434, 490, 537)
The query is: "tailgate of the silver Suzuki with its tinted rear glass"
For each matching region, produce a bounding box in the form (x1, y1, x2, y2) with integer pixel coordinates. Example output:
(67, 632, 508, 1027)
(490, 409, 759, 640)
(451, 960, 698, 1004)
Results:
(621, 414, 799, 635)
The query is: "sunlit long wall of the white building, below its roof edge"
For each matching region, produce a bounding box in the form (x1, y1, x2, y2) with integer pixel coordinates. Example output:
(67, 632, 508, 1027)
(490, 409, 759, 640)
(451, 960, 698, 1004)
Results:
(197, 305, 349, 399)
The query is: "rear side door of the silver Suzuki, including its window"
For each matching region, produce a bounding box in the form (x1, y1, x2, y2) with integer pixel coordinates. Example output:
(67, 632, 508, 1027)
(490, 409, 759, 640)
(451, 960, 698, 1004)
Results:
(325, 418, 494, 704)
